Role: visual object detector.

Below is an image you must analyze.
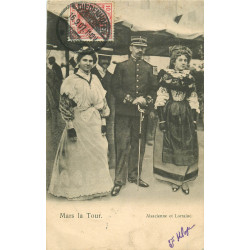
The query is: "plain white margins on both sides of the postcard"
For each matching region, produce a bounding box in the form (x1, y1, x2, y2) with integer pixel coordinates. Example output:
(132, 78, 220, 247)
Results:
(0, 0, 250, 250)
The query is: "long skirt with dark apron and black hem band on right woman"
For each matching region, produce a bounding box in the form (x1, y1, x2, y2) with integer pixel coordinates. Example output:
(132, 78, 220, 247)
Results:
(154, 100, 199, 185)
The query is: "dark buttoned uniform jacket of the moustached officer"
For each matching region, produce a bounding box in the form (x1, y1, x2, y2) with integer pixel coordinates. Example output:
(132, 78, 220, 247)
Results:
(111, 57, 157, 116)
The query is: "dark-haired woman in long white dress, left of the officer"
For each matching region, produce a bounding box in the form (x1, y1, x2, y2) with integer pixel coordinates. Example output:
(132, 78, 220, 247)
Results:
(49, 48, 113, 200)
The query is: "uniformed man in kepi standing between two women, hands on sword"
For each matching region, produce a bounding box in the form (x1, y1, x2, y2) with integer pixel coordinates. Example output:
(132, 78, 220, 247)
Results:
(111, 36, 156, 196)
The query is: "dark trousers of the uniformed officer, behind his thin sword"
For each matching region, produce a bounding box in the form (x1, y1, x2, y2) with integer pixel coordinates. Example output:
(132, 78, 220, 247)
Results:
(115, 114, 148, 185)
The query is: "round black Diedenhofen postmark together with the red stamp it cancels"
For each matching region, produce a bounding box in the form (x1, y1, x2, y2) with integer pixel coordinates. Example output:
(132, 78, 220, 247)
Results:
(56, 2, 113, 52)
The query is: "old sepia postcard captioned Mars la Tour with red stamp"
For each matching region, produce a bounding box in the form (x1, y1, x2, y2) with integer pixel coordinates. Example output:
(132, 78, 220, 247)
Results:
(46, 0, 204, 250)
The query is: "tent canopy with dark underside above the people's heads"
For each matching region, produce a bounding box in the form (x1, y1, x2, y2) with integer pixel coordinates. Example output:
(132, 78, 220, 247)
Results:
(47, 2, 204, 58)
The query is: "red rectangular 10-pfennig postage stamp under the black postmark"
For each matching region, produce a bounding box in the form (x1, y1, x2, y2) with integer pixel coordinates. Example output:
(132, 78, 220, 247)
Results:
(68, 2, 114, 42)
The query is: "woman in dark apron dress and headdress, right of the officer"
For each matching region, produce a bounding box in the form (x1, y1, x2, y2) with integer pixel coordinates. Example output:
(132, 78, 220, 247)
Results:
(154, 46, 199, 194)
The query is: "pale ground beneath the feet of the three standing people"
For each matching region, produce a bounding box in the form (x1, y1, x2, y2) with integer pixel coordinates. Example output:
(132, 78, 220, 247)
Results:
(47, 124, 204, 202)
